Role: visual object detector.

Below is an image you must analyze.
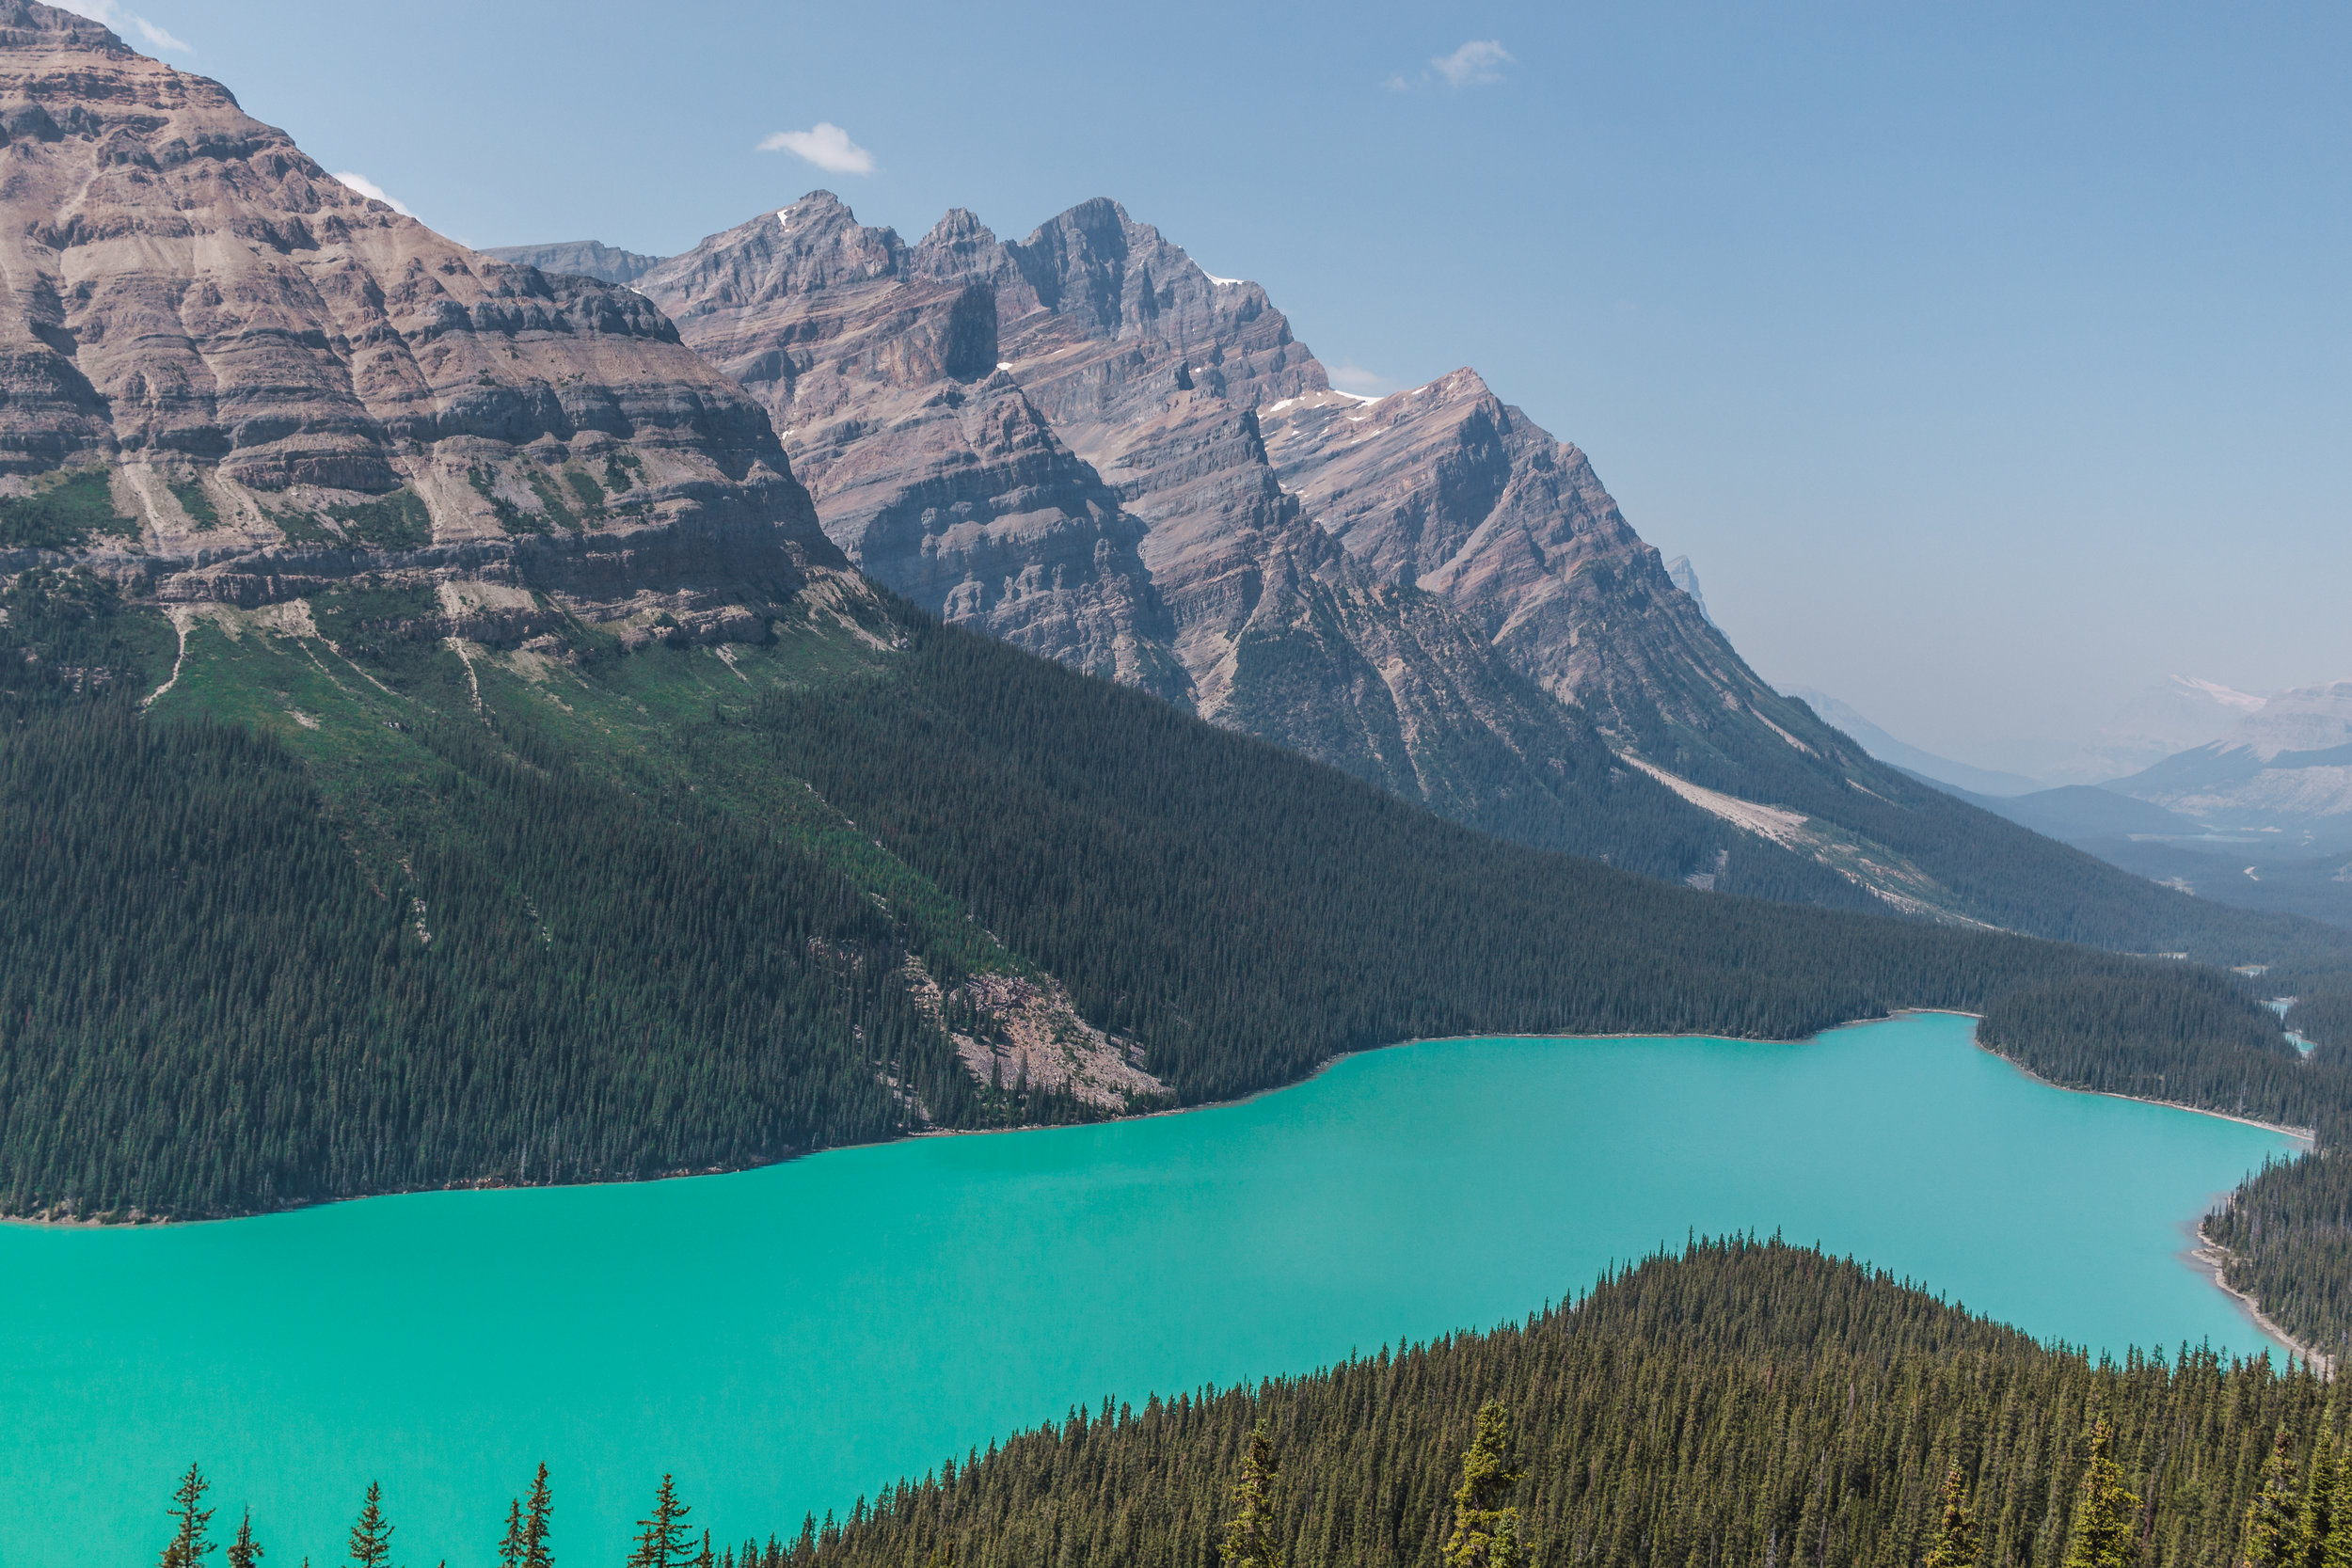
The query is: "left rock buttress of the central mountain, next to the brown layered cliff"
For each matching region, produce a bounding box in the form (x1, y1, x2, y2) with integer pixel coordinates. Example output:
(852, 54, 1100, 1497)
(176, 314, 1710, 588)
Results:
(640, 190, 1193, 703)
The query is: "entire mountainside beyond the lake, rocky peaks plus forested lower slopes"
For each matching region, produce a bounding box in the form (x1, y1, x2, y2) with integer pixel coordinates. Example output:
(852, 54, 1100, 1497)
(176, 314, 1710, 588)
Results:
(0, 0, 2352, 1215)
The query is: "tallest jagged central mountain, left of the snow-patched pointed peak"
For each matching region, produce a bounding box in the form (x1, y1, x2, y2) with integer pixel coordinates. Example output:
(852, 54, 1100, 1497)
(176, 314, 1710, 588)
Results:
(638, 193, 1769, 877)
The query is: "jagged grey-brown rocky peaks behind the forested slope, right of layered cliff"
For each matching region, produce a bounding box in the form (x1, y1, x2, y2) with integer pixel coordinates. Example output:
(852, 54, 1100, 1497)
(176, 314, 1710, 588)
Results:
(497, 190, 2286, 947)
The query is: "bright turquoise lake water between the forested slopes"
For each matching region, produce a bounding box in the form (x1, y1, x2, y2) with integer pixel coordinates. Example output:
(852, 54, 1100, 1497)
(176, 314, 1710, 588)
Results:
(0, 1016, 2291, 1568)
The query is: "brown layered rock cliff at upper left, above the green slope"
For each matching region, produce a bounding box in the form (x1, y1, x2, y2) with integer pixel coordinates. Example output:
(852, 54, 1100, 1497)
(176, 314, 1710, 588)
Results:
(0, 0, 842, 618)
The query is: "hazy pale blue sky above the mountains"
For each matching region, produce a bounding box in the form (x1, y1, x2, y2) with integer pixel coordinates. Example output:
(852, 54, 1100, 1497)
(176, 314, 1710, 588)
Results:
(85, 0, 2352, 764)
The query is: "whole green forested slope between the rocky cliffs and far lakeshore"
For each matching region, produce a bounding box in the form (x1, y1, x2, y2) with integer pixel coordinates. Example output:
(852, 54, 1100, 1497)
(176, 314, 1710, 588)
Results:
(0, 569, 2333, 1215)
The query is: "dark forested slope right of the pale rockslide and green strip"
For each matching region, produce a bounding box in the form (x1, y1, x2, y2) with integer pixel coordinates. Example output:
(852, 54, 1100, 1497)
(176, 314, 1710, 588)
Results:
(746, 618, 2314, 1096)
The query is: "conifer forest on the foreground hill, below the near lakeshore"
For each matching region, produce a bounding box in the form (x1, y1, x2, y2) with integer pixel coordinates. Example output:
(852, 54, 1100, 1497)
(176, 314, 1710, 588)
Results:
(142, 1239, 2352, 1568)
